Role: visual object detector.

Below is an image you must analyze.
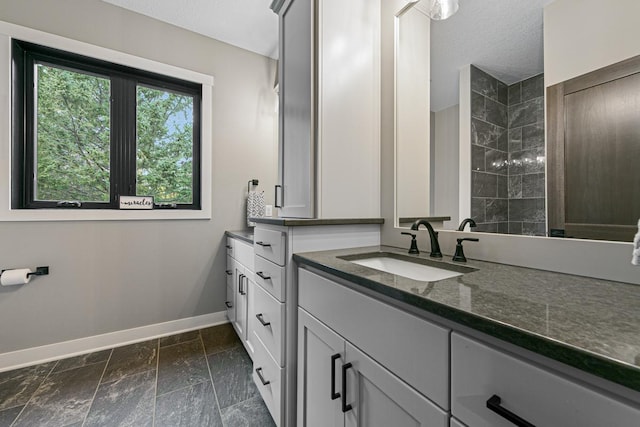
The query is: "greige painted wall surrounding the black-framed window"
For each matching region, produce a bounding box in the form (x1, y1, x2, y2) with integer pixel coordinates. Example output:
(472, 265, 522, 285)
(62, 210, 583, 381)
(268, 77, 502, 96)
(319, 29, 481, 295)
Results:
(0, 0, 277, 353)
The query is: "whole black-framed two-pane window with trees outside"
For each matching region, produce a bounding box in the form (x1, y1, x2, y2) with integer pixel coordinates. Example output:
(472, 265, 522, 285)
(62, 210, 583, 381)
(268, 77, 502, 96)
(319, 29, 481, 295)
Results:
(12, 40, 202, 209)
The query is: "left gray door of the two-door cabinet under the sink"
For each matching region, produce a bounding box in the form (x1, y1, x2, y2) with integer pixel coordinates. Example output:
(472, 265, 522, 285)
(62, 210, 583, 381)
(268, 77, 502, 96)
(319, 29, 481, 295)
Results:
(297, 308, 344, 427)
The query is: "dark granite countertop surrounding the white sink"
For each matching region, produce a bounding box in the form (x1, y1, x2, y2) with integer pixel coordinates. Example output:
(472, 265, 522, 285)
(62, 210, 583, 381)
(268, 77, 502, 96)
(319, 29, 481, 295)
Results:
(293, 246, 640, 391)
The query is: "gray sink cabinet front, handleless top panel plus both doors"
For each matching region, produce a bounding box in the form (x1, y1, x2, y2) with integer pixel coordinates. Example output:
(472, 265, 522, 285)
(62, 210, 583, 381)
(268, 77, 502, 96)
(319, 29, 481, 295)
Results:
(297, 269, 449, 427)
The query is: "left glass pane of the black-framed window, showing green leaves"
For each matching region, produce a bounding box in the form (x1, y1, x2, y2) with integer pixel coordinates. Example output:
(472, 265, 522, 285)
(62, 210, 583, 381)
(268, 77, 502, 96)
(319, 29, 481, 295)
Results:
(35, 64, 111, 202)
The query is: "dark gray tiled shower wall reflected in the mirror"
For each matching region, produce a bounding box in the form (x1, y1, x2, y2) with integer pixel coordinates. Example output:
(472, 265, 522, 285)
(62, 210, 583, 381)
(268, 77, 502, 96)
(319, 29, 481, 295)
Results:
(471, 66, 545, 235)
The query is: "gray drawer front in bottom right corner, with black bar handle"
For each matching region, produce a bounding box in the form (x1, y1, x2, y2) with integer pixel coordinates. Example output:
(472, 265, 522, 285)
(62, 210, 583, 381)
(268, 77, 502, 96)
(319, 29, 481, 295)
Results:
(451, 333, 640, 427)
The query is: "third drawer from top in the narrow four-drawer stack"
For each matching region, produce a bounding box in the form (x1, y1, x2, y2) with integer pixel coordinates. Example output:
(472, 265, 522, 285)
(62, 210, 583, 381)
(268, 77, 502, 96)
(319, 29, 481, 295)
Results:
(251, 286, 285, 366)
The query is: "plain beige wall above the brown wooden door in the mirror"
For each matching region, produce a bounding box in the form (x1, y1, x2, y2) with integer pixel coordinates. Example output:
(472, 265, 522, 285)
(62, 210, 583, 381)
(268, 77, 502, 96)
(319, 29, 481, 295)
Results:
(544, 0, 640, 86)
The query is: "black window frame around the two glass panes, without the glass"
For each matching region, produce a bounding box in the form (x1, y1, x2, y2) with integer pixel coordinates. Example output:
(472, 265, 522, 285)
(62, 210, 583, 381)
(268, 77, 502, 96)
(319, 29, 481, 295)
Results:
(11, 39, 202, 210)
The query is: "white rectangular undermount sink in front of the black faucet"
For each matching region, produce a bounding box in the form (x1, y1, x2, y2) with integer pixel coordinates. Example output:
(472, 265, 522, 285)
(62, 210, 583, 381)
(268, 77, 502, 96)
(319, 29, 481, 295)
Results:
(340, 252, 476, 282)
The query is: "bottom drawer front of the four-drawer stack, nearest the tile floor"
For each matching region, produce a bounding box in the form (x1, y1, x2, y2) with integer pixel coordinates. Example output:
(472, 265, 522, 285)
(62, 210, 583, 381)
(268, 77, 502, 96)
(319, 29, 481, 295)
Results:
(253, 335, 284, 427)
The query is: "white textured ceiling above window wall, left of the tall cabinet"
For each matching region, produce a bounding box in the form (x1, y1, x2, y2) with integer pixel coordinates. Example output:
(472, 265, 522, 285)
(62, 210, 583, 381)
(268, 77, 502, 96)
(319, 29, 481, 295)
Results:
(103, 0, 278, 58)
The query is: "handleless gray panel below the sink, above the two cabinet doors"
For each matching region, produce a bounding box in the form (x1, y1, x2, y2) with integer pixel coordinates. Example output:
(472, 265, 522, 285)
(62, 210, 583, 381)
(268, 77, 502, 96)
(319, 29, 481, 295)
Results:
(298, 269, 450, 410)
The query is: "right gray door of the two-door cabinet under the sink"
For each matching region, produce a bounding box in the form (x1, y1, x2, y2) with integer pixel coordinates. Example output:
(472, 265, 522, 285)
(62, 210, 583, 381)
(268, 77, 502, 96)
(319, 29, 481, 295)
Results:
(342, 342, 449, 427)
